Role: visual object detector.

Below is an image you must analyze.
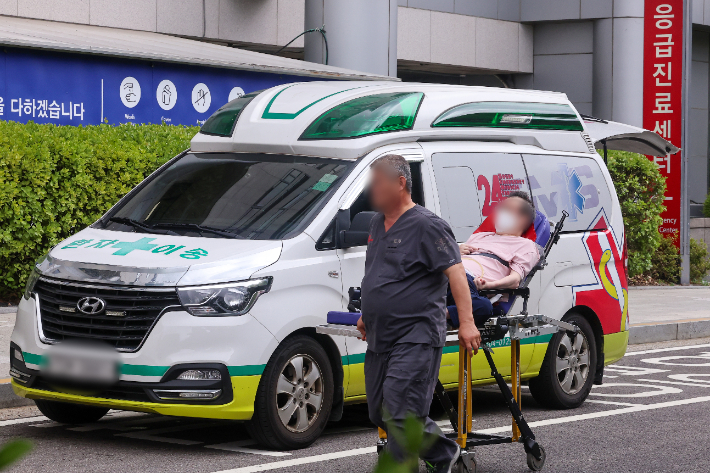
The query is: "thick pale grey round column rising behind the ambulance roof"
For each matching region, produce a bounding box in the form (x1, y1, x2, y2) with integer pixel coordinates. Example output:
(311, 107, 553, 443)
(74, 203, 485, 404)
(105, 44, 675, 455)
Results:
(305, 0, 398, 77)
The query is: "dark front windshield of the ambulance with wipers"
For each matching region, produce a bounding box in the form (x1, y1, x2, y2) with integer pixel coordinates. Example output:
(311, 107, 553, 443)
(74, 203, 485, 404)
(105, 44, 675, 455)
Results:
(104, 153, 354, 240)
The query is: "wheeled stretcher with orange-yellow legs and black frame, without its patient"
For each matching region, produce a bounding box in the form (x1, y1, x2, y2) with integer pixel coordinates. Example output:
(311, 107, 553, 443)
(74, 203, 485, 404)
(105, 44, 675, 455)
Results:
(316, 211, 580, 473)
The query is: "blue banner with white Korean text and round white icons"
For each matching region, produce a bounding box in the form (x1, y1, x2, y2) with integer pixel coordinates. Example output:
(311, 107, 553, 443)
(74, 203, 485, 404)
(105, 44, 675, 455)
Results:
(0, 48, 313, 125)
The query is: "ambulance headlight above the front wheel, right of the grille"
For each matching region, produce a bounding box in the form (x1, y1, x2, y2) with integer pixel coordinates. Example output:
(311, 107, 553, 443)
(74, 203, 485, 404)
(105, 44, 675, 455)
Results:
(178, 277, 273, 316)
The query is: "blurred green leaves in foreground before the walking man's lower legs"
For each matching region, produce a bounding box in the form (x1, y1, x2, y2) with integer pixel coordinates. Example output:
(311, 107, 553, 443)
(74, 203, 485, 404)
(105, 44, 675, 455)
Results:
(374, 415, 436, 473)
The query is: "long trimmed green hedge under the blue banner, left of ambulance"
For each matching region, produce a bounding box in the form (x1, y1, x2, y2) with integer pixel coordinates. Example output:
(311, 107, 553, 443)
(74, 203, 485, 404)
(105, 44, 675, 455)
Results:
(0, 122, 198, 298)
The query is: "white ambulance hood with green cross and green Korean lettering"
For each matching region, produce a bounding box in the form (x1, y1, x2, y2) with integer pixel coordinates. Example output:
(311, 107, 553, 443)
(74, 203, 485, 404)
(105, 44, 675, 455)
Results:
(37, 228, 282, 286)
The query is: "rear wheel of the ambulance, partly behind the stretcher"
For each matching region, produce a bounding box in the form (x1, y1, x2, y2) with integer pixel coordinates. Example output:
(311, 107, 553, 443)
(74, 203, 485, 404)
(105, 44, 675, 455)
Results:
(530, 313, 597, 409)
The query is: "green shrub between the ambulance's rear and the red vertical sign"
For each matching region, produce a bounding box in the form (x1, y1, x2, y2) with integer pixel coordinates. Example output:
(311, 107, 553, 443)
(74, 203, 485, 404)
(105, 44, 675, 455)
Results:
(608, 151, 666, 276)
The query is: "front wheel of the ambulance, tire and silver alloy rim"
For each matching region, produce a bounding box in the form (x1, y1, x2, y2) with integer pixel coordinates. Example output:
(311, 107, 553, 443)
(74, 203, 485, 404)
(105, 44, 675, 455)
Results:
(247, 335, 334, 450)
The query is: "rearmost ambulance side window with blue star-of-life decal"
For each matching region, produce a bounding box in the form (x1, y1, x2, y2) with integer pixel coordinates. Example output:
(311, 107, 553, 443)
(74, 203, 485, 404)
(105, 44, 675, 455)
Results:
(523, 155, 612, 232)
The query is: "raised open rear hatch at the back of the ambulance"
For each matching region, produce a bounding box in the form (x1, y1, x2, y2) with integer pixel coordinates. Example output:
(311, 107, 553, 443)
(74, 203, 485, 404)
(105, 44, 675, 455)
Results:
(582, 115, 680, 157)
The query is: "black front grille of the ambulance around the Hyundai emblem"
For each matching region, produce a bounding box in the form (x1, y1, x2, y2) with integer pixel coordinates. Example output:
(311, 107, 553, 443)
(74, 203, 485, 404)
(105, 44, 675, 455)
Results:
(35, 278, 180, 351)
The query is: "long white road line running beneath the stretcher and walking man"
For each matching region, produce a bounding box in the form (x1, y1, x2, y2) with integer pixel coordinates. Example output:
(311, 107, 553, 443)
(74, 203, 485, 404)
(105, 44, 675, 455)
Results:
(209, 396, 710, 473)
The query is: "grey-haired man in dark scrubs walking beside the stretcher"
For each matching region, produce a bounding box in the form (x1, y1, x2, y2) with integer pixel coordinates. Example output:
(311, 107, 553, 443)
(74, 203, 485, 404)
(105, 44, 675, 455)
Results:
(358, 155, 481, 473)
